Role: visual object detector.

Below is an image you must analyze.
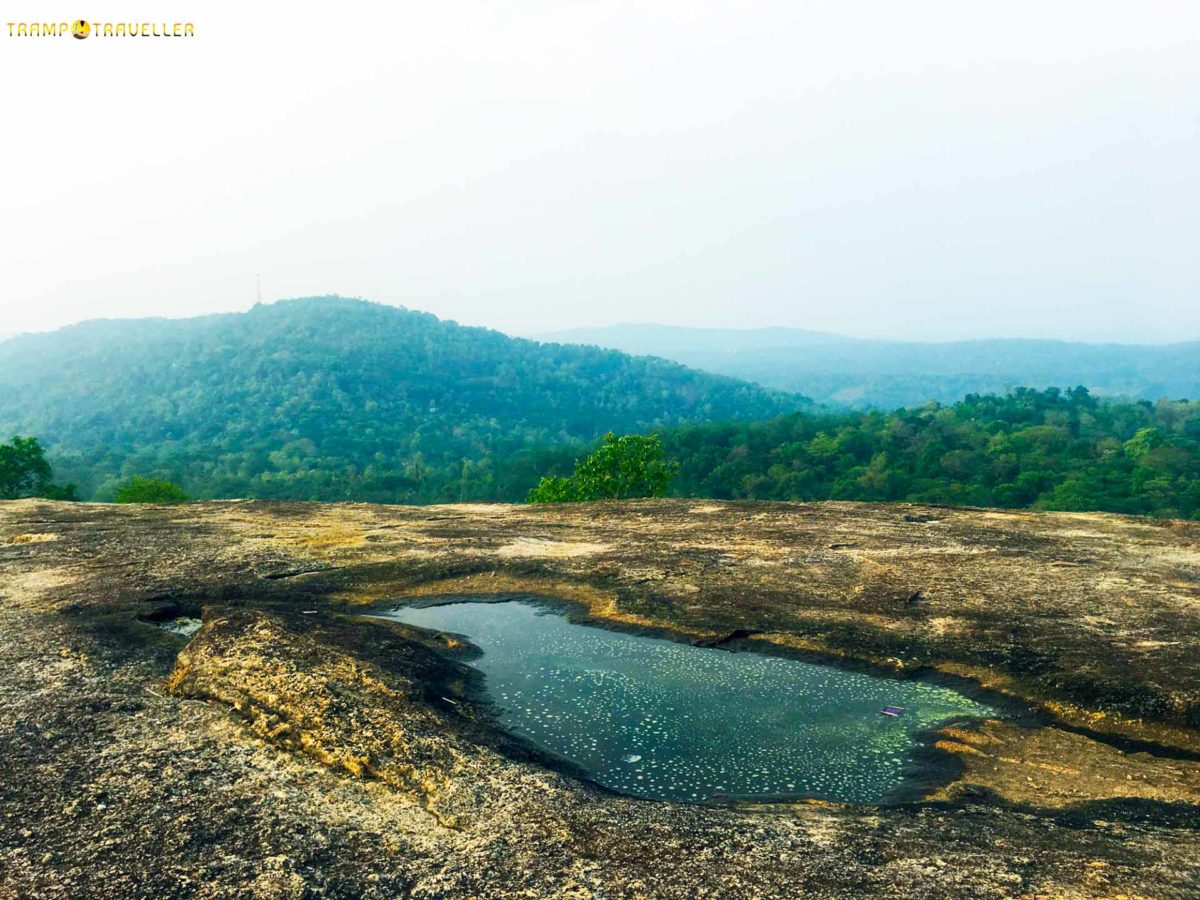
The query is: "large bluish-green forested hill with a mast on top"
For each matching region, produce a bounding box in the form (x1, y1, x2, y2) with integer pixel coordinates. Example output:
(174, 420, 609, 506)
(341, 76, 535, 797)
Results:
(0, 298, 805, 503)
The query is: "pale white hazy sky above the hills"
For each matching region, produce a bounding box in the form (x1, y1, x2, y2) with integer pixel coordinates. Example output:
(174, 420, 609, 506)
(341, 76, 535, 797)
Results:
(0, 0, 1200, 341)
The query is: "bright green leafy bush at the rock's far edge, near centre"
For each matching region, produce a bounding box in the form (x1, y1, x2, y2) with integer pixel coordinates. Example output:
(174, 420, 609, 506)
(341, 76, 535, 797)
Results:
(528, 432, 678, 503)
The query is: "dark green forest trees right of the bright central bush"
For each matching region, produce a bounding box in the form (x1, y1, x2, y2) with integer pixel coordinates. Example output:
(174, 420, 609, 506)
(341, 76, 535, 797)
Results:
(664, 388, 1200, 518)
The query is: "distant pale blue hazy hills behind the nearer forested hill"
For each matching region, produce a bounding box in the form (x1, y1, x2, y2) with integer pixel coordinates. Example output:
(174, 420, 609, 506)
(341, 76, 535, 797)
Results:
(539, 324, 1200, 409)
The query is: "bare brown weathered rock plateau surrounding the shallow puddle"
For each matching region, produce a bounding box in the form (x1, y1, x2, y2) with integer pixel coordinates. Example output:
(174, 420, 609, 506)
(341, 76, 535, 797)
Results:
(0, 500, 1200, 899)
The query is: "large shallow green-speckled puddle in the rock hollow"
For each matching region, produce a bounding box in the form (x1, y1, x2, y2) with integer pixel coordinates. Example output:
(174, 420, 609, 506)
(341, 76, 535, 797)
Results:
(372, 601, 997, 803)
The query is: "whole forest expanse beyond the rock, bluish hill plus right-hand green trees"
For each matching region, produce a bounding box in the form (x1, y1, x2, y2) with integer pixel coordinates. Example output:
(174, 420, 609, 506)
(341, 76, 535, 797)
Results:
(0, 298, 1200, 518)
